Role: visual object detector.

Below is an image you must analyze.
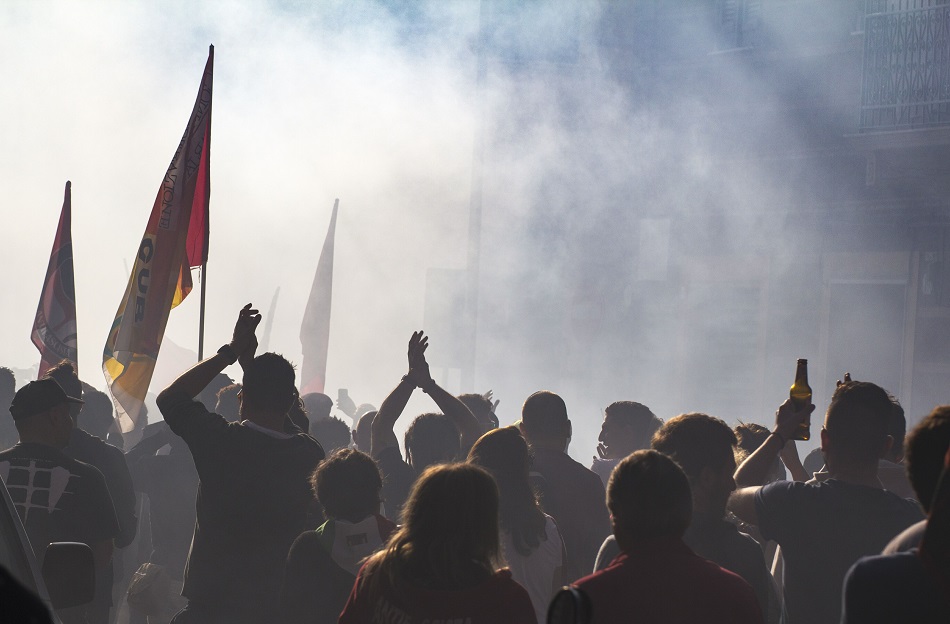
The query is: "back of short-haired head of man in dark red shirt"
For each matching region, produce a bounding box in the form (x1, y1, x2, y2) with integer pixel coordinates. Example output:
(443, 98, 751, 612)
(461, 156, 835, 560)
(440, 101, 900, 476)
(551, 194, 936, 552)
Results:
(607, 450, 693, 551)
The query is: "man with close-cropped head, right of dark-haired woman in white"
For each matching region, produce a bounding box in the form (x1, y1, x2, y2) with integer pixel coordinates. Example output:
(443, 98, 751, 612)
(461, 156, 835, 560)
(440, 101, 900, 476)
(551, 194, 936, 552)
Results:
(521, 391, 610, 579)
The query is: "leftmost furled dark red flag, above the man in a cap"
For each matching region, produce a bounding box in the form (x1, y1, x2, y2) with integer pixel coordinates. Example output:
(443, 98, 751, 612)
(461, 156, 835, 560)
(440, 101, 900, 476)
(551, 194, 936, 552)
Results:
(30, 181, 79, 377)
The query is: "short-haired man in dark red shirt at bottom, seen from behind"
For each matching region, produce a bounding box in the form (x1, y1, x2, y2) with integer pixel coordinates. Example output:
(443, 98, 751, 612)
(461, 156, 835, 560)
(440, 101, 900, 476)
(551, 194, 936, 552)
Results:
(574, 450, 762, 624)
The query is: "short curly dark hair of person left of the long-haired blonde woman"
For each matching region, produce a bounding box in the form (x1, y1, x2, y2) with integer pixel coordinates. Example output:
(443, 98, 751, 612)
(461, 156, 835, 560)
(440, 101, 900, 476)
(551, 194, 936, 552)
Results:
(310, 449, 383, 522)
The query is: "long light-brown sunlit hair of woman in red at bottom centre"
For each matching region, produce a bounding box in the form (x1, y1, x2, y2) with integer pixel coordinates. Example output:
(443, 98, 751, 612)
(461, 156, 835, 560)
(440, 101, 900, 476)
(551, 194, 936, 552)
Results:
(361, 464, 499, 594)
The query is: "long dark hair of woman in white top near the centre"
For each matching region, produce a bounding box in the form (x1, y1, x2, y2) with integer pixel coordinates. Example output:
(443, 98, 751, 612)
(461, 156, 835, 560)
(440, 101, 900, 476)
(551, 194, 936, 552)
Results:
(468, 427, 548, 557)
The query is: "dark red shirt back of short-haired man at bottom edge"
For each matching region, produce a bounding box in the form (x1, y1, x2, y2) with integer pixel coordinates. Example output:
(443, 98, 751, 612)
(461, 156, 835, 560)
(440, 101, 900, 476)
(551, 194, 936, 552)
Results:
(575, 537, 762, 624)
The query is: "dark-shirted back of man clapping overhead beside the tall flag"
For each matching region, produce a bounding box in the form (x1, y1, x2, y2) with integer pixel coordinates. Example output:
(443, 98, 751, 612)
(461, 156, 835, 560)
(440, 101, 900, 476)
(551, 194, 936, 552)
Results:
(162, 396, 323, 612)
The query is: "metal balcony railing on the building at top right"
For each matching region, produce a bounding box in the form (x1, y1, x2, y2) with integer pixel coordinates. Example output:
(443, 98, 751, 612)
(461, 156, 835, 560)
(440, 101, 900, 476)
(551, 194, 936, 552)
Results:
(861, 0, 950, 132)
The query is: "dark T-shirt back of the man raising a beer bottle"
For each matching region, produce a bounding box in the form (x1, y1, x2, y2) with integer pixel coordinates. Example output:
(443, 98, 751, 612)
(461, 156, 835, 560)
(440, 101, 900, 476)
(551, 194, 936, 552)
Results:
(755, 479, 922, 624)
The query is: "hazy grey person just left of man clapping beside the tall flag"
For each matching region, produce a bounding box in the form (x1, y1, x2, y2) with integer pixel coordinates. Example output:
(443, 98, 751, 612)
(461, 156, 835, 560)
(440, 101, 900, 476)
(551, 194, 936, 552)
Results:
(126, 422, 198, 624)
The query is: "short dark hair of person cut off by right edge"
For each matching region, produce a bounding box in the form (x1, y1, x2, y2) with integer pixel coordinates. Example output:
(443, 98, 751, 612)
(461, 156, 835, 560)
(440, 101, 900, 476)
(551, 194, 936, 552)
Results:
(904, 405, 950, 513)
